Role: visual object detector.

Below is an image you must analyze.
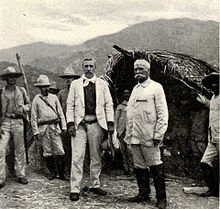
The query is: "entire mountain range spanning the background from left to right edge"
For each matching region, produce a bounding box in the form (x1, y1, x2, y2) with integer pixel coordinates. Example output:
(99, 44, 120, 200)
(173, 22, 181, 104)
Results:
(0, 18, 219, 74)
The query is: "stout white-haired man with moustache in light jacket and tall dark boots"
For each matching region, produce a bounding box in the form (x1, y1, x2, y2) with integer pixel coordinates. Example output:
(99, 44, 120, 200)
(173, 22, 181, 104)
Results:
(126, 59, 168, 209)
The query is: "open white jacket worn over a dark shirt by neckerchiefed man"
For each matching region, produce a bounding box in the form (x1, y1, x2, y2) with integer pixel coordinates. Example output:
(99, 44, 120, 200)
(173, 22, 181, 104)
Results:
(66, 77, 114, 130)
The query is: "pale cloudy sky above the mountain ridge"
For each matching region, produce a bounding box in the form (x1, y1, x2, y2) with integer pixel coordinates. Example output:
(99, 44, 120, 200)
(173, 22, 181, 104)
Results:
(0, 0, 219, 49)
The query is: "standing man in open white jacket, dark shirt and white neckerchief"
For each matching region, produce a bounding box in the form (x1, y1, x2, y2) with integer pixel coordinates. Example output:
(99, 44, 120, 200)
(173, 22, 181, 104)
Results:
(66, 58, 114, 201)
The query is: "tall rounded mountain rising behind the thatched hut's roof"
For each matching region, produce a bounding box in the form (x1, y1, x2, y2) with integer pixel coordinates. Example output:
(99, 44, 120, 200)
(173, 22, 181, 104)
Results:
(84, 18, 219, 62)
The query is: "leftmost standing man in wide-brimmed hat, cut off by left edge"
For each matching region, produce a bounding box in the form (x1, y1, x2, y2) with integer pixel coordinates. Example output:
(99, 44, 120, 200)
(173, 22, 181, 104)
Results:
(0, 67, 30, 188)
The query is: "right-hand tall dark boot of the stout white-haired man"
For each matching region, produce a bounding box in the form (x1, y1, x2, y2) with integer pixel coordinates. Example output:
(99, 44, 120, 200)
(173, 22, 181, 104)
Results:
(150, 164, 167, 209)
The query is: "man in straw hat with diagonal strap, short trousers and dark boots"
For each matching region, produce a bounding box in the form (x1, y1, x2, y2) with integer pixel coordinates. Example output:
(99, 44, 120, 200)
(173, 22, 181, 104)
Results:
(31, 75, 66, 180)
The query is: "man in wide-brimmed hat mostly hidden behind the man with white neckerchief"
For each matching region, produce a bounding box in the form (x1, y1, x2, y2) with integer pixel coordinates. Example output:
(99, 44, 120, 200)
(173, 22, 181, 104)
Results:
(58, 67, 80, 176)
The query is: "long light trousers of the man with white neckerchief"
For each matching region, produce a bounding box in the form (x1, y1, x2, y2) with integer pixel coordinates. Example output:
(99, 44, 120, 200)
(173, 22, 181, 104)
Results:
(70, 122, 104, 193)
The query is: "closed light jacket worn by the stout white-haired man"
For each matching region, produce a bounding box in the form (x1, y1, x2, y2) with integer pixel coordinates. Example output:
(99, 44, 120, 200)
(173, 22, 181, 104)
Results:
(126, 78, 168, 146)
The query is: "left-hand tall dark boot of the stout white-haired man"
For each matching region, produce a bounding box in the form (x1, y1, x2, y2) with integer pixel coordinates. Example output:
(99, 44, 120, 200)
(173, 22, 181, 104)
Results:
(128, 168, 151, 202)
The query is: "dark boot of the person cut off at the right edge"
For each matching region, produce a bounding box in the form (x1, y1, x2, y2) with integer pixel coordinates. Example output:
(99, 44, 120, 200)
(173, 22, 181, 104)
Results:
(200, 163, 219, 197)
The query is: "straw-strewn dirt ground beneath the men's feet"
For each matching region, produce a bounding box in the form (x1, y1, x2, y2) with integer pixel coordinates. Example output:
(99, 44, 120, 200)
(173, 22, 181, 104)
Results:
(0, 169, 219, 209)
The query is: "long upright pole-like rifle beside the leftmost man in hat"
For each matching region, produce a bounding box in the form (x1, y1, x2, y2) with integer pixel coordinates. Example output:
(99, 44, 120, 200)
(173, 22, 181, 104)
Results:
(16, 53, 30, 165)
